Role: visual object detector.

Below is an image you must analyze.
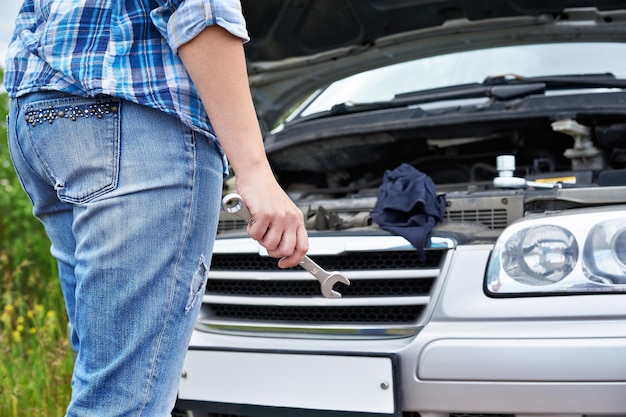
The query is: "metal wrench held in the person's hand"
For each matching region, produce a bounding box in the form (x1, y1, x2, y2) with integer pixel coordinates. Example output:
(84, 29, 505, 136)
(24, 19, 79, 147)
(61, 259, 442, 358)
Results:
(222, 193, 350, 298)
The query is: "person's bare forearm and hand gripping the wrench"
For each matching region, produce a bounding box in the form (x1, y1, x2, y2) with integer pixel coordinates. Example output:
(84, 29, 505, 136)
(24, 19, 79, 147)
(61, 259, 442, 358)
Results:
(178, 26, 308, 267)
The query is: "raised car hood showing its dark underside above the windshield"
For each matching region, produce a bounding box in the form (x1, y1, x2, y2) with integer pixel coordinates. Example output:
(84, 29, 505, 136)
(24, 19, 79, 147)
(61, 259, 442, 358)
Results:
(242, 0, 626, 131)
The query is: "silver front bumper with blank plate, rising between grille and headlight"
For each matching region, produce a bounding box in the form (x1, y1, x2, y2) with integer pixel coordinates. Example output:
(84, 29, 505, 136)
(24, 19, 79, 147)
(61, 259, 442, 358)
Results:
(174, 246, 626, 417)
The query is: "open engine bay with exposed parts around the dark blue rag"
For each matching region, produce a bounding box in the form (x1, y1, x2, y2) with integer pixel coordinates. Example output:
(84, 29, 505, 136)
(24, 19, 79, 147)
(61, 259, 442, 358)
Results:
(244, 102, 626, 241)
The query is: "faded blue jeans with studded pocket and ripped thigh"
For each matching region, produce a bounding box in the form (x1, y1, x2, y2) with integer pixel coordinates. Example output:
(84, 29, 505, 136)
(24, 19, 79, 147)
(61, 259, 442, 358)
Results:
(9, 92, 224, 417)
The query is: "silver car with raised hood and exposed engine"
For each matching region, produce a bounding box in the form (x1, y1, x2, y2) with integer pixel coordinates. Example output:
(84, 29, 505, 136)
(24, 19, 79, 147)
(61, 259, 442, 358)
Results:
(173, 0, 626, 417)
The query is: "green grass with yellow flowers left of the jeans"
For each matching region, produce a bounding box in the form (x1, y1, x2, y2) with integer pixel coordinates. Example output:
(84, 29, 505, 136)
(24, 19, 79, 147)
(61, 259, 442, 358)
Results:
(0, 68, 73, 417)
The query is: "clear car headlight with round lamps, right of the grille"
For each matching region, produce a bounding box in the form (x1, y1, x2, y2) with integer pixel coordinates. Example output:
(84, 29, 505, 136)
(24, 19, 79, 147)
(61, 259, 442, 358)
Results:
(485, 208, 626, 296)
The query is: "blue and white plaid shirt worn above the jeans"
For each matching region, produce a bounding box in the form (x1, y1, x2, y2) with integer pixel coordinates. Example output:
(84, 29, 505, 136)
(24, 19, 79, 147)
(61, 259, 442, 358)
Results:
(4, 0, 248, 171)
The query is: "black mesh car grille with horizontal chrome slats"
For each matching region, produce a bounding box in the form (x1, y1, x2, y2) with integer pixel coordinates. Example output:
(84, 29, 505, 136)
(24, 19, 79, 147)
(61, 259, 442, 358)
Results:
(198, 244, 447, 337)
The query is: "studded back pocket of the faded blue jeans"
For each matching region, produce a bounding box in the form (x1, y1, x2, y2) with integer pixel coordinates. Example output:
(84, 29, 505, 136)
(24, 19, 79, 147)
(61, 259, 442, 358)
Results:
(21, 96, 121, 204)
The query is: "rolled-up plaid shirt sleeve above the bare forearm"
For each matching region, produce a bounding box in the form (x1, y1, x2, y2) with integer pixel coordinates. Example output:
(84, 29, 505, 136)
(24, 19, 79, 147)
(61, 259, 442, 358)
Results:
(150, 0, 249, 53)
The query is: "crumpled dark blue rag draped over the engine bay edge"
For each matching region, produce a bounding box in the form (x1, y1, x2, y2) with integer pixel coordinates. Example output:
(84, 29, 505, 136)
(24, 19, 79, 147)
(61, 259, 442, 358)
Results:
(372, 164, 446, 259)
